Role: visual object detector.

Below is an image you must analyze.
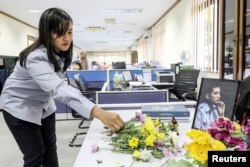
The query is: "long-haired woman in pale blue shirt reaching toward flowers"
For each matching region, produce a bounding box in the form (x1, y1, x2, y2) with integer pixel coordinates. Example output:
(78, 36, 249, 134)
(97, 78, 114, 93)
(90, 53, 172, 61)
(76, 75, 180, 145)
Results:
(0, 8, 124, 167)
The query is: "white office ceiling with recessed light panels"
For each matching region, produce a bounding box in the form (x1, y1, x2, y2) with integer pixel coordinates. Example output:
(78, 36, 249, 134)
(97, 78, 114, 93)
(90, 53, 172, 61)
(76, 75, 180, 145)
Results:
(0, 0, 178, 51)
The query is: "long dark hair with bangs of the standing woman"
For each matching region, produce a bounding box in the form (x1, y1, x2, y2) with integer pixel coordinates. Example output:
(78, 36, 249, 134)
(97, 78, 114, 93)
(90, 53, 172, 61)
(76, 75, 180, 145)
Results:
(19, 8, 73, 72)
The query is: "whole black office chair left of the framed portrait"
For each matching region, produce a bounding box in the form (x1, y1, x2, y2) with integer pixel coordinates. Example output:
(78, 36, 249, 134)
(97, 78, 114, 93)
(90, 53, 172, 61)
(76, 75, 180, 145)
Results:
(169, 69, 200, 101)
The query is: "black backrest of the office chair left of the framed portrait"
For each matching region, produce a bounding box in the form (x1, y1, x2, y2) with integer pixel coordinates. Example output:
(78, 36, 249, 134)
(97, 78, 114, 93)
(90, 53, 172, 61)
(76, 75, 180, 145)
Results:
(174, 69, 200, 96)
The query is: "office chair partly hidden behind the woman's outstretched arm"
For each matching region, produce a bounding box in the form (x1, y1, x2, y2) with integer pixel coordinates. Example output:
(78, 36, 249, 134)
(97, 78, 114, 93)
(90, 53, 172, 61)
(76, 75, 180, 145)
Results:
(68, 74, 95, 147)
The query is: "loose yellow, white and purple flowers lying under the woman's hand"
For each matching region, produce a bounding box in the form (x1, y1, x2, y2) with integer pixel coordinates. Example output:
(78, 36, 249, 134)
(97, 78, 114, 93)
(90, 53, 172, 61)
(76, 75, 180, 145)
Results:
(92, 113, 181, 165)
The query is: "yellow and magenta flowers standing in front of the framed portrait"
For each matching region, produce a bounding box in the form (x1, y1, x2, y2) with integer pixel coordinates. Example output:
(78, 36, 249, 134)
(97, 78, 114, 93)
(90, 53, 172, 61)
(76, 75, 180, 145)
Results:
(167, 117, 250, 167)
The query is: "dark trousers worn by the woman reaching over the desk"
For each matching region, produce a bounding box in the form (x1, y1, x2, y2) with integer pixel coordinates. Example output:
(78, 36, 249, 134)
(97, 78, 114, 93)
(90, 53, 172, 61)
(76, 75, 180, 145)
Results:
(3, 111, 59, 167)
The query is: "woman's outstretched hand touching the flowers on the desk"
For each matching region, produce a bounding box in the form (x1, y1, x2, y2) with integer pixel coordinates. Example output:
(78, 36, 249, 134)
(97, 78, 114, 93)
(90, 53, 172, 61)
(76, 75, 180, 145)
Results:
(91, 106, 124, 132)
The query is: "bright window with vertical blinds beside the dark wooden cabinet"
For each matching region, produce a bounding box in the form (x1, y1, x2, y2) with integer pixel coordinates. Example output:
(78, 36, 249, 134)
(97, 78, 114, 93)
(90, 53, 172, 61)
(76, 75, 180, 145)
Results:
(193, 0, 218, 72)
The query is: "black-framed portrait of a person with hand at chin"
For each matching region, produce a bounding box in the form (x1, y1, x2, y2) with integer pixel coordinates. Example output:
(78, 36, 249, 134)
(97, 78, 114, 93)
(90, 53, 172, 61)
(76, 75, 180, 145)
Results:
(192, 78, 240, 131)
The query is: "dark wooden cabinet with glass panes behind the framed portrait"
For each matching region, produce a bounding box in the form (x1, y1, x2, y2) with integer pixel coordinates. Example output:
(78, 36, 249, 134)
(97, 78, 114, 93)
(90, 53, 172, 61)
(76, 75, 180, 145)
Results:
(219, 0, 250, 80)
